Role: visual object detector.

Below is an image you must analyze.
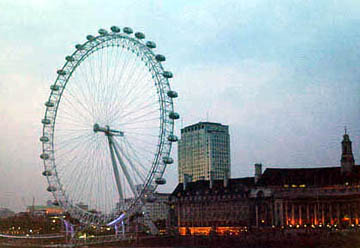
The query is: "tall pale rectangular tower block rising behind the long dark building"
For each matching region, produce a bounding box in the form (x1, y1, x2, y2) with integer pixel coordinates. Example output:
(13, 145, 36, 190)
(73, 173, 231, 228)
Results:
(178, 122, 230, 183)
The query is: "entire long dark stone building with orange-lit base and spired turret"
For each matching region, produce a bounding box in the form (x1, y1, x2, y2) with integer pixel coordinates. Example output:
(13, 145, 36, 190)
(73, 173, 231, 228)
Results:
(170, 133, 360, 234)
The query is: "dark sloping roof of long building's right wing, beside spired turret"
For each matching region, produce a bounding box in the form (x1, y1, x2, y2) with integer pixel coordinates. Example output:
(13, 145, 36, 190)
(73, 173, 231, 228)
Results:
(257, 165, 360, 186)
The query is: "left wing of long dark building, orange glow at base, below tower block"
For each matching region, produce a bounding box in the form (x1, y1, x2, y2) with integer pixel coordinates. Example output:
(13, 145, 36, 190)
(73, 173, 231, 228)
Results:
(170, 177, 254, 234)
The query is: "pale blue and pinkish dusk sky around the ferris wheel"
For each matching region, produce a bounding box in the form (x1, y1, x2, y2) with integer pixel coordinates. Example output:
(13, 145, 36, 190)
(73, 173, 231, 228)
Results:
(0, 0, 360, 211)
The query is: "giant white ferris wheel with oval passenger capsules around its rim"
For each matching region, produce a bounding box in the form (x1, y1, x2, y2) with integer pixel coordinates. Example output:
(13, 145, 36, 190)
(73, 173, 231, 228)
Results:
(40, 26, 179, 224)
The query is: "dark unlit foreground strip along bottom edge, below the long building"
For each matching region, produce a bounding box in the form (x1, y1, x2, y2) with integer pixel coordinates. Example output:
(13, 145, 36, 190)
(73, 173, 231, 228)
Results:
(95, 230, 360, 248)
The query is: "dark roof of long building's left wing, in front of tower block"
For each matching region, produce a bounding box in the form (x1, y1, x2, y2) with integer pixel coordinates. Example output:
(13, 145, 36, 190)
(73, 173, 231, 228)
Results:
(171, 177, 254, 196)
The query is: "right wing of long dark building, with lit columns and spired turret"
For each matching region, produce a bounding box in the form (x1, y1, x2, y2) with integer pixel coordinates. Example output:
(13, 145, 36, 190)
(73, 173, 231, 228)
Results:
(255, 133, 360, 229)
